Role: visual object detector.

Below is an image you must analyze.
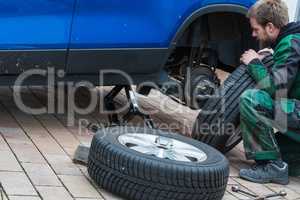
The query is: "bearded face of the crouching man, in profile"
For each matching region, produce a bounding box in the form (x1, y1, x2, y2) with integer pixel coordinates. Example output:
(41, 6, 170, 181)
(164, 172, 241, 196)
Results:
(250, 17, 274, 47)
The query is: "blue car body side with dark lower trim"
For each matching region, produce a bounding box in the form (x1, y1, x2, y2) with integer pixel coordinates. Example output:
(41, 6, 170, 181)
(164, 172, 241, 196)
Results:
(0, 0, 255, 84)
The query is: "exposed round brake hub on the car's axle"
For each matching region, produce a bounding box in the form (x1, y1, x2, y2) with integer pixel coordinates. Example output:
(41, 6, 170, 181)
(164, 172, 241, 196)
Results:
(185, 66, 219, 110)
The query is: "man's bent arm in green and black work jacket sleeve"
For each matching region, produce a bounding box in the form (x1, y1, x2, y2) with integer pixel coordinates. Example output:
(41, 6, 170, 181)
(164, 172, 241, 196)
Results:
(248, 39, 300, 96)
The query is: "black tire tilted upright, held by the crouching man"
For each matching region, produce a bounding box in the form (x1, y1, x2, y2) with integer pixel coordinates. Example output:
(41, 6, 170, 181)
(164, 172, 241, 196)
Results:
(192, 56, 273, 153)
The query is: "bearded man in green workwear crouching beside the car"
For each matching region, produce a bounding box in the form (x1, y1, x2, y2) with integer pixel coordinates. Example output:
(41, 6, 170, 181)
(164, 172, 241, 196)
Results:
(240, 0, 300, 184)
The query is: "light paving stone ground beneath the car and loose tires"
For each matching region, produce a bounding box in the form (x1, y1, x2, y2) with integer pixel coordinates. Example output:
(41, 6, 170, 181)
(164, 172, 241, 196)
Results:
(0, 87, 300, 200)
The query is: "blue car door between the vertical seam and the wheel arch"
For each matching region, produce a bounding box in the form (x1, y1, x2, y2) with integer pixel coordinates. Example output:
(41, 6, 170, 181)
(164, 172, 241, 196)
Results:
(68, 0, 220, 74)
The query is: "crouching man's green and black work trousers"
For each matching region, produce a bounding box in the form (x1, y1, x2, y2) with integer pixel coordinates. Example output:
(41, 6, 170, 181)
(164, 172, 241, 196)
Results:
(240, 89, 300, 161)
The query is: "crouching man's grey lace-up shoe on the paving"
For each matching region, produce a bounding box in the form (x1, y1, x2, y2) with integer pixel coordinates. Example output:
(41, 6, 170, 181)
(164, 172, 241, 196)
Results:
(240, 161, 289, 185)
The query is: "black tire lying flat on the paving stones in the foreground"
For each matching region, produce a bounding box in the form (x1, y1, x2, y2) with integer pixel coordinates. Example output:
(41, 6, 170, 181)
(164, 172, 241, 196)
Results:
(88, 127, 229, 200)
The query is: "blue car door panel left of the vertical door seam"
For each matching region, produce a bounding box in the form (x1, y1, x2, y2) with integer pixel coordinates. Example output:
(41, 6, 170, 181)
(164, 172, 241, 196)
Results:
(0, 0, 75, 75)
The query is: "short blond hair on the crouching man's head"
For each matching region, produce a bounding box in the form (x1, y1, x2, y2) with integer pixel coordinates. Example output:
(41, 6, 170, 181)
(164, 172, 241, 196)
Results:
(247, 0, 289, 29)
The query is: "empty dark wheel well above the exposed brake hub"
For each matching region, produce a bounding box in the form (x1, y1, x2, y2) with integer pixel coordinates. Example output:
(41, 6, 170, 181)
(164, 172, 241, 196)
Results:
(165, 12, 258, 71)
